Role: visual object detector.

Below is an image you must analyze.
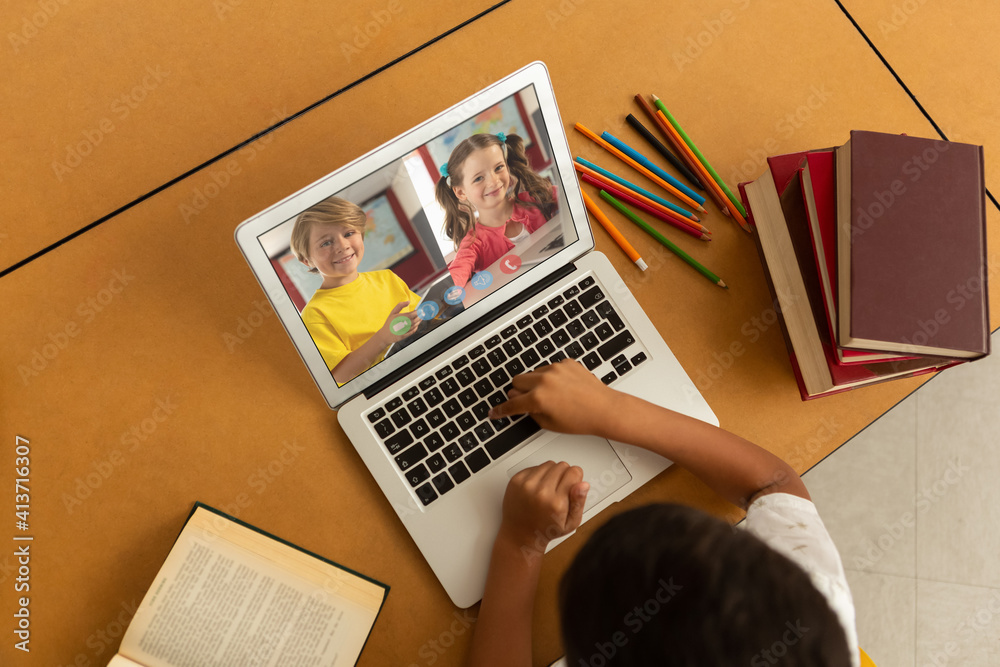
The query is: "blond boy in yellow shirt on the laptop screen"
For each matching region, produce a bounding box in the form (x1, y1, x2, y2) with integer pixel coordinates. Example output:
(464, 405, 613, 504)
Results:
(291, 197, 420, 384)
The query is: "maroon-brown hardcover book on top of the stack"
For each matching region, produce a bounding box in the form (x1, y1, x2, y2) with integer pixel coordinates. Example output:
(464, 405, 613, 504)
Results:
(836, 130, 990, 359)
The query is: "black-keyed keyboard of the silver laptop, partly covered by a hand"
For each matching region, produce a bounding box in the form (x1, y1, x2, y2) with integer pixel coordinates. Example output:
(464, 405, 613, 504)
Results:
(368, 276, 647, 506)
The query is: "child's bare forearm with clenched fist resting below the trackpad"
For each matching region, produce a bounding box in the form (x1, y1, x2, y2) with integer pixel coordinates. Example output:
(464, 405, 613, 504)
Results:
(469, 461, 589, 667)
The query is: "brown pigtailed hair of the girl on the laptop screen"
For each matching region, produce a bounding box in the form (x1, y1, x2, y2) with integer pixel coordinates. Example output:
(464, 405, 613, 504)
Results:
(434, 134, 558, 248)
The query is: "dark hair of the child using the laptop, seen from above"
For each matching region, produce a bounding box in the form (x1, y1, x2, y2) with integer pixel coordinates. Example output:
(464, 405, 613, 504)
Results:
(559, 505, 857, 667)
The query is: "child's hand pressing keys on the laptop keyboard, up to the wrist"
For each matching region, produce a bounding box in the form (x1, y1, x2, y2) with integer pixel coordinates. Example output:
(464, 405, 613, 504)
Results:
(490, 359, 618, 437)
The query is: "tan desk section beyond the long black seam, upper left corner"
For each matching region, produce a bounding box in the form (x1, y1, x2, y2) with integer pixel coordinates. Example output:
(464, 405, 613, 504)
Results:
(0, 0, 495, 271)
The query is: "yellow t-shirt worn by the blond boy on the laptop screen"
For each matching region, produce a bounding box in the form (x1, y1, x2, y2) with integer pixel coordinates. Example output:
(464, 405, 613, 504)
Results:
(302, 270, 420, 378)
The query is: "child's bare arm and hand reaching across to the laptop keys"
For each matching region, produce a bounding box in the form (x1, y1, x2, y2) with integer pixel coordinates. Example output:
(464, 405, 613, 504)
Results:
(490, 360, 809, 508)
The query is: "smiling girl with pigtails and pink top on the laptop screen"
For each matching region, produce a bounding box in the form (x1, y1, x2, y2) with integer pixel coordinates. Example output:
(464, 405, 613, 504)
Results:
(435, 132, 558, 287)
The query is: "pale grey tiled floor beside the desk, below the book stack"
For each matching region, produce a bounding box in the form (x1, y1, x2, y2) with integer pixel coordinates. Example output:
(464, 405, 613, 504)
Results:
(803, 334, 1000, 667)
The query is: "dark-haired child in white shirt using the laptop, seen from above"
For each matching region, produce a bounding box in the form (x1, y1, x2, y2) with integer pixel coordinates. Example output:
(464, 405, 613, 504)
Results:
(469, 360, 860, 667)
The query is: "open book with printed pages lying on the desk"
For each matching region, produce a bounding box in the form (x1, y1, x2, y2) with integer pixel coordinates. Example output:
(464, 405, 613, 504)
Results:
(108, 503, 389, 667)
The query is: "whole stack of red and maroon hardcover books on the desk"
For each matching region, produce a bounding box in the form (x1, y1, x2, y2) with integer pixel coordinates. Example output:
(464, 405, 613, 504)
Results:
(739, 131, 990, 400)
